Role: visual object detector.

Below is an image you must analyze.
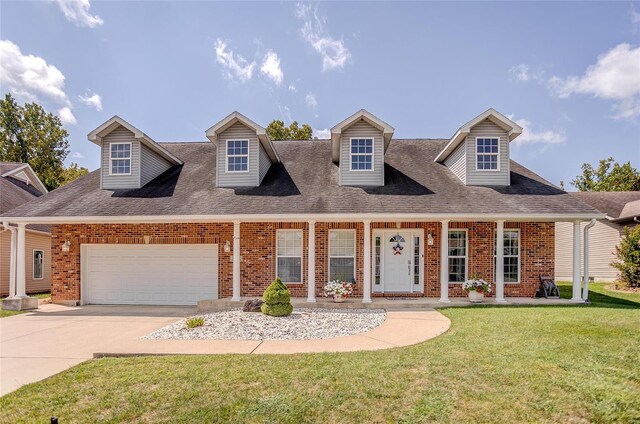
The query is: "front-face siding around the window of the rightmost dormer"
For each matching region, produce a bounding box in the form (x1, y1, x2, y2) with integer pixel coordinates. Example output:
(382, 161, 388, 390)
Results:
(464, 119, 511, 186)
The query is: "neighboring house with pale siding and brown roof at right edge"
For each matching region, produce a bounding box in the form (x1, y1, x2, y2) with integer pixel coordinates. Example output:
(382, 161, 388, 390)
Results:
(556, 191, 640, 282)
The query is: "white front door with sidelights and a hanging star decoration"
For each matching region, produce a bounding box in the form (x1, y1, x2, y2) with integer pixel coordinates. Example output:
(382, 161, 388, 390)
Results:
(373, 230, 422, 293)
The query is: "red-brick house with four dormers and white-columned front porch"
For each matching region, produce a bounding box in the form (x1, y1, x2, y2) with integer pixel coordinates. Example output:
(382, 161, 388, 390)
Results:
(1, 109, 603, 305)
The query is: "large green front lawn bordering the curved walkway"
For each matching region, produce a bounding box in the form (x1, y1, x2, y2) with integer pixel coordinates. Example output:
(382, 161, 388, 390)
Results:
(0, 284, 640, 423)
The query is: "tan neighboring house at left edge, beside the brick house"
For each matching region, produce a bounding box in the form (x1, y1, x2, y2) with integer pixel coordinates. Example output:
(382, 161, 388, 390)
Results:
(0, 162, 51, 296)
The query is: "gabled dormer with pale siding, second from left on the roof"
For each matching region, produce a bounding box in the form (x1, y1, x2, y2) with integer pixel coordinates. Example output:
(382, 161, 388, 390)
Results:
(206, 112, 280, 187)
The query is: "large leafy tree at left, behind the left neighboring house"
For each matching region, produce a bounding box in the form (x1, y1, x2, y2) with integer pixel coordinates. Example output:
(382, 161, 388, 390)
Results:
(0, 94, 88, 190)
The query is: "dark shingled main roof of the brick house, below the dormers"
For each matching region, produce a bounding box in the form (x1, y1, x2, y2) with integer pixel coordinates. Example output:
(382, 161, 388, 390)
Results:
(6, 139, 601, 222)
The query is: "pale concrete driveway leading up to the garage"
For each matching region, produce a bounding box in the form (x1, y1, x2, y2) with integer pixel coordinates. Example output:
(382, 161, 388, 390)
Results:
(0, 305, 195, 396)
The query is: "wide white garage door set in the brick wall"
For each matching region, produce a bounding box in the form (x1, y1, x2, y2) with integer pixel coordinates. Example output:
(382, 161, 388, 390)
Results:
(82, 244, 218, 305)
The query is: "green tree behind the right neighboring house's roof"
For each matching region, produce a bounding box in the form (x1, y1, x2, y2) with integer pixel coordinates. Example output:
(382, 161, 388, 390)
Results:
(571, 157, 640, 191)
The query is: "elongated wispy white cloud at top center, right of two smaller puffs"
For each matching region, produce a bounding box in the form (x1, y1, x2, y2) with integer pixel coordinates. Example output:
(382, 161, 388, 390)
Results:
(296, 3, 351, 71)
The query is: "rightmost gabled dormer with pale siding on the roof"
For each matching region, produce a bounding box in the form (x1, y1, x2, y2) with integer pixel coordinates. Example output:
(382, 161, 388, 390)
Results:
(435, 109, 522, 186)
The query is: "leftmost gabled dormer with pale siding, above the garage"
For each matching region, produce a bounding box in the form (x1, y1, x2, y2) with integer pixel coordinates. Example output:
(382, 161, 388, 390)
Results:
(88, 116, 182, 190)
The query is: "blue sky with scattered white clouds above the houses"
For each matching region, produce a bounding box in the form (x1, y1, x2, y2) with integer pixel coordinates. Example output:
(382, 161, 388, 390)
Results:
(0, 0, 640, 188)
